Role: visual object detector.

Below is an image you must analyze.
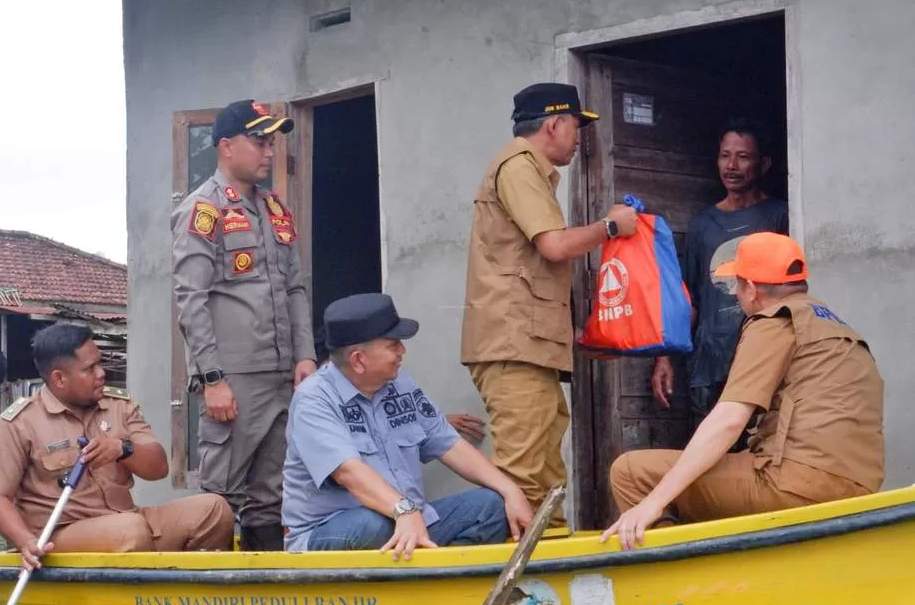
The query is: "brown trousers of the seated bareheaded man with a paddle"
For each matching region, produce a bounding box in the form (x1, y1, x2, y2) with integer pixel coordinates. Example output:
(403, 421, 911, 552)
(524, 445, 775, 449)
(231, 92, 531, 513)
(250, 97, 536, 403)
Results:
(51, 494, 235, 552)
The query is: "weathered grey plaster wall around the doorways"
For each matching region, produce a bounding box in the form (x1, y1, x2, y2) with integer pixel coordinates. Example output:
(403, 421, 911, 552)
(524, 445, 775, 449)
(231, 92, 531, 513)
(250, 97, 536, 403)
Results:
(124, 0, 915, 510)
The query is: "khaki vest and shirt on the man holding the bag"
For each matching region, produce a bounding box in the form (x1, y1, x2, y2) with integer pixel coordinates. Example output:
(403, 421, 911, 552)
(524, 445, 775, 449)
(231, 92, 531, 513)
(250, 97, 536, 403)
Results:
(461, 137, 572, 371)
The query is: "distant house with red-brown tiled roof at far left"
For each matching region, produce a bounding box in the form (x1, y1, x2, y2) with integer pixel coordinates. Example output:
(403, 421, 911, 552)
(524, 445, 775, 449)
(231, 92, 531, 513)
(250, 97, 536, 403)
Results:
(0, 230, 127, 408)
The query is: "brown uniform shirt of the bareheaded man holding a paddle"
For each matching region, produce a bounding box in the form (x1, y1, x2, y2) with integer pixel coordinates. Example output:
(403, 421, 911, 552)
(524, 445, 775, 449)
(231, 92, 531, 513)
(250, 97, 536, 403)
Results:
(0, 387, 156, 535)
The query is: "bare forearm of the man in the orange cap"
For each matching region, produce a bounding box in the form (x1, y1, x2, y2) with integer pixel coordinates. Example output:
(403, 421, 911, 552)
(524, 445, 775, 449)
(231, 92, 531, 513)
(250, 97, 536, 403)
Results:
(646, 401, 754, 508)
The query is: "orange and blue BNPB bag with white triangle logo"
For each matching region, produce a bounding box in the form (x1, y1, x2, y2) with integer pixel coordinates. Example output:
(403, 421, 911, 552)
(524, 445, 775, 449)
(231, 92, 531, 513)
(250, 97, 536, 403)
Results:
(578, 194, 693, 357)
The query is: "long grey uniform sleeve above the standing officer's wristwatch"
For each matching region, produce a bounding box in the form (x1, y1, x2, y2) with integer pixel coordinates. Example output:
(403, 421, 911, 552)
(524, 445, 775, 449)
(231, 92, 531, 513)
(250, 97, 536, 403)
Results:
(172, 198, 220, 372)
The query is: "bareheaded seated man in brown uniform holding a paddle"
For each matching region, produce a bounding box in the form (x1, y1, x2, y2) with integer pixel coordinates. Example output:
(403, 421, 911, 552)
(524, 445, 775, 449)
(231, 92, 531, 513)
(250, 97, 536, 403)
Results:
(0, 324, 234, 569)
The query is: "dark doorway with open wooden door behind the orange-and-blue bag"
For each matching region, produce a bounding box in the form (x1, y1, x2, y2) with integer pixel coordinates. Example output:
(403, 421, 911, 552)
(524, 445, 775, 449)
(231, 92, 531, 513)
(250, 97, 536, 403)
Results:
(571, 14, 787, 528)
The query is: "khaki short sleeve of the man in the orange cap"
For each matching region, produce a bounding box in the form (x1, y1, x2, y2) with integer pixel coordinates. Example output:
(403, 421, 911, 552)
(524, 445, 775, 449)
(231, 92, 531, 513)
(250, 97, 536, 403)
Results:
(720, 316, 796, 411)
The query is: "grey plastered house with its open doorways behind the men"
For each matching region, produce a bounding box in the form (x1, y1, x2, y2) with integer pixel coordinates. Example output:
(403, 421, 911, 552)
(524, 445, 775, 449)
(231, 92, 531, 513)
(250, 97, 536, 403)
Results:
(123, 0, 915, 525)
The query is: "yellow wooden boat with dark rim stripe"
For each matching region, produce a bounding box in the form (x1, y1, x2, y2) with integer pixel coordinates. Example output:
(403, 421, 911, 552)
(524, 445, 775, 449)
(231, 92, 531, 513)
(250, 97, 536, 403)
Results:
(0, 487, 915, 605)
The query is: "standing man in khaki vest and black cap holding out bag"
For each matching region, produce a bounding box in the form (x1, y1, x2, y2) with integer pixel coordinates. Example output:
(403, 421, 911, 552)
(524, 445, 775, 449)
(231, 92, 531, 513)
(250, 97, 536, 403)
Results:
(461, 83, 636, 525)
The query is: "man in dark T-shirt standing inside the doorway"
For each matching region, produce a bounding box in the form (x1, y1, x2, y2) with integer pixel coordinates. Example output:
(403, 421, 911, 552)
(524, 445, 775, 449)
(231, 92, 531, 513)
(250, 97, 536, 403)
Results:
(651, 118, 788, 433)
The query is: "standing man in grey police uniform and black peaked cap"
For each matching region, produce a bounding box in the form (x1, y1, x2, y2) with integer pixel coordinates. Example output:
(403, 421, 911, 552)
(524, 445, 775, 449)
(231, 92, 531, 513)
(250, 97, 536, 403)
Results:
(172, 100, 315, 550)
